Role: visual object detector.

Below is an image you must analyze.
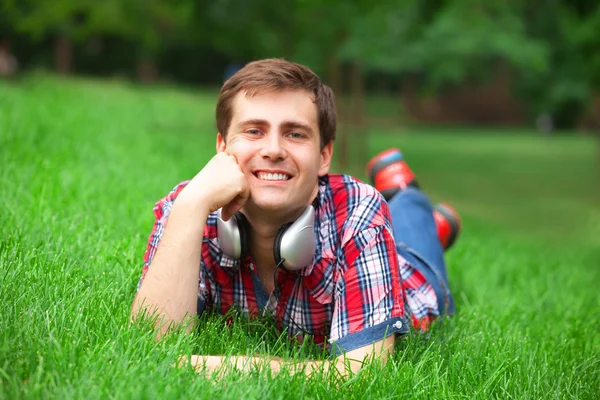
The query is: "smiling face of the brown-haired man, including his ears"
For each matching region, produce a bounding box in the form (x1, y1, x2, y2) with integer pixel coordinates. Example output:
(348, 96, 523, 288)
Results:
(217, 91, 332, 214)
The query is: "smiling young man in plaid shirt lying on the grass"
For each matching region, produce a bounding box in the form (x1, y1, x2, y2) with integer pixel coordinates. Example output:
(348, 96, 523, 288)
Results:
(132, 59, 460, 373)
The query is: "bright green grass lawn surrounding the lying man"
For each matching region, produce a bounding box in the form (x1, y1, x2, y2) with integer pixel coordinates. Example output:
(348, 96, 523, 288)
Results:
(0, 76, 600, 399)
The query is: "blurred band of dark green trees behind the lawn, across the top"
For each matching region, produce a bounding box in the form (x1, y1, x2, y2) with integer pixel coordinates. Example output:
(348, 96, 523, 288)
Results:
(0, 0, 600, 131)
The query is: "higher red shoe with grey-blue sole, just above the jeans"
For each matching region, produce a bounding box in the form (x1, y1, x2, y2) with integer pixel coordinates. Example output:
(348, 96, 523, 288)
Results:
(367, 148, 419, 200)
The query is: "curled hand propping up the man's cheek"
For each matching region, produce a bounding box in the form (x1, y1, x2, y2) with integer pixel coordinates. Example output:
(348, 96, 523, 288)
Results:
(179, 152, 250, 221)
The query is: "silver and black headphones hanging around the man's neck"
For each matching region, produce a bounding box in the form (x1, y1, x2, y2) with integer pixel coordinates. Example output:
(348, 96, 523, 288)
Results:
(217, 205, 316, 271)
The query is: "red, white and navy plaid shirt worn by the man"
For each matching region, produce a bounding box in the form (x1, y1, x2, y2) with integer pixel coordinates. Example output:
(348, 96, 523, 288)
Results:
(138, 174, 439, 354)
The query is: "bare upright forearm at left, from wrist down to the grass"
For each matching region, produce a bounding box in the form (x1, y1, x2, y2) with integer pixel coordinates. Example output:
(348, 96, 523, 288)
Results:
(131, 196, 208, 334)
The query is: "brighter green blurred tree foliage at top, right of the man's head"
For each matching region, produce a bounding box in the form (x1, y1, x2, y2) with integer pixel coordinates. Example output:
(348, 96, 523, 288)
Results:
(342, 0, 549, 121)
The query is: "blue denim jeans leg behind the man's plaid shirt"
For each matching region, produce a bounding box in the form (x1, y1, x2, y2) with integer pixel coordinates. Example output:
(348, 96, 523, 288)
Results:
(388, 187, 454, 315)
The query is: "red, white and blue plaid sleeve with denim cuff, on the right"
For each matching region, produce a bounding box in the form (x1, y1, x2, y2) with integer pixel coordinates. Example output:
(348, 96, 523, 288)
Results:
(329, 195, 409, 355)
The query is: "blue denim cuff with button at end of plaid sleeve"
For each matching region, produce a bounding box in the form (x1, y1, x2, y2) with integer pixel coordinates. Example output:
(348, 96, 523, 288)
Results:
(330, 317, 409, 357)
